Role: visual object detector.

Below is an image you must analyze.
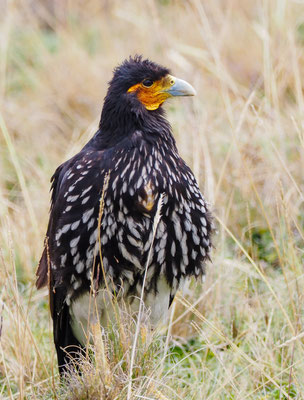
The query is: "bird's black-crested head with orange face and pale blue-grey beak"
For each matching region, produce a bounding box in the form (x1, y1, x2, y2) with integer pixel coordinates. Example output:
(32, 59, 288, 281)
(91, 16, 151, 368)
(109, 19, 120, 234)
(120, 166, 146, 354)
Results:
(101, 56, 196, 135)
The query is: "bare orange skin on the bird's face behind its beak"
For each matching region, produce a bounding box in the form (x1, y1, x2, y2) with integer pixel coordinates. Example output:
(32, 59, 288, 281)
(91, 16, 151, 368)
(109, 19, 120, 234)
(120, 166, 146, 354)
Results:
(128, 75, 175, 110)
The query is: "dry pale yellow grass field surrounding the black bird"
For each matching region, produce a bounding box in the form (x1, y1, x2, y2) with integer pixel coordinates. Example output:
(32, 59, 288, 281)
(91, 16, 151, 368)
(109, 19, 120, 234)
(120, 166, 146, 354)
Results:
(0, 0, 304, 400)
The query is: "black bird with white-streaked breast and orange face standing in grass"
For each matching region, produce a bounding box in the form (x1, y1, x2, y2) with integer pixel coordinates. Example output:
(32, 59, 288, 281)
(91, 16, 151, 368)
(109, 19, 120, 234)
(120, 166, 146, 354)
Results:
(36, 55, 213, 376)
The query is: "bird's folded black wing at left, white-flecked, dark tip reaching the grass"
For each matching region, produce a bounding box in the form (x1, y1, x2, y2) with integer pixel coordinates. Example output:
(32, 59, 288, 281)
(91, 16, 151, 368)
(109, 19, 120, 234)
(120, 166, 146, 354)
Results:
(36, 150, 110, 369)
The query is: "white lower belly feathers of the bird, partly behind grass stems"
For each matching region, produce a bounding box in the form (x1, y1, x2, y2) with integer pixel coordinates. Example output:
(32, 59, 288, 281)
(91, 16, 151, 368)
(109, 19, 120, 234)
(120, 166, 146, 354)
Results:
(69, 276, 171, 345)
